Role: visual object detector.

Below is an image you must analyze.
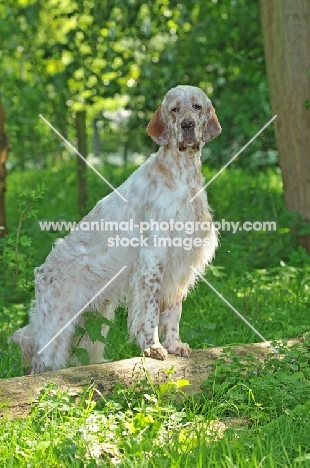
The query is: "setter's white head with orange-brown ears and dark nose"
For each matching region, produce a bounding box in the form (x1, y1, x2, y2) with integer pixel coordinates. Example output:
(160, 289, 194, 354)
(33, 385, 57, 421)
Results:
(147, 86, 222, 150)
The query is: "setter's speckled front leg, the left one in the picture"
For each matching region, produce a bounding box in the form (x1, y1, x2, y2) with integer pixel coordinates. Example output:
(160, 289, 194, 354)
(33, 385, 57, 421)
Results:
(128, 249, 168, 359)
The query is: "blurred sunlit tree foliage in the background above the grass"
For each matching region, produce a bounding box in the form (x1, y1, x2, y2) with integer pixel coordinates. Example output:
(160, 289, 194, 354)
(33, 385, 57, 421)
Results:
(0, 0, 276, 167)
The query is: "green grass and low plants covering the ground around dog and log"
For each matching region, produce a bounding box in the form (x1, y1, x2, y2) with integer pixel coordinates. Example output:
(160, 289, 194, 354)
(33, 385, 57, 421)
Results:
(0, 163, 310, 468)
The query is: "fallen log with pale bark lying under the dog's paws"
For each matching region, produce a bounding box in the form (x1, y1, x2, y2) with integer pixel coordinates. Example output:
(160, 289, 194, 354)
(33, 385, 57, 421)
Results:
(0, 339, 302, 418)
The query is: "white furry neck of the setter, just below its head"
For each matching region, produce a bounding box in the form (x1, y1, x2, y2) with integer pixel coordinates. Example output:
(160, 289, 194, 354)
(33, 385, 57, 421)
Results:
(157, 146, 203, 186)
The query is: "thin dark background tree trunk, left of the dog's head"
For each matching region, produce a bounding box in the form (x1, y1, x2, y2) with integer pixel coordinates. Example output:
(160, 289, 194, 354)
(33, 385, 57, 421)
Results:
(75, 111, 87, 218)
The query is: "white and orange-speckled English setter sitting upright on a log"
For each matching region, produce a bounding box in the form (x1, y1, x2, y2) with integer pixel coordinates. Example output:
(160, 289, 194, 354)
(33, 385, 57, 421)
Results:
(11, 86, 221, 374)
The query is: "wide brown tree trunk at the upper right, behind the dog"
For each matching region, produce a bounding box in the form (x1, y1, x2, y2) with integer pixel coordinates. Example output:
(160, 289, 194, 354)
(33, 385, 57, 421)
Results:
(260, 0, 310, 254)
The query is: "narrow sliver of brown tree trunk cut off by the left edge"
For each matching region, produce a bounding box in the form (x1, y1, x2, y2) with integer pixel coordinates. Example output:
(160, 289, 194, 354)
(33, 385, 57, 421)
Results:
(0, 98, 8, 237)
